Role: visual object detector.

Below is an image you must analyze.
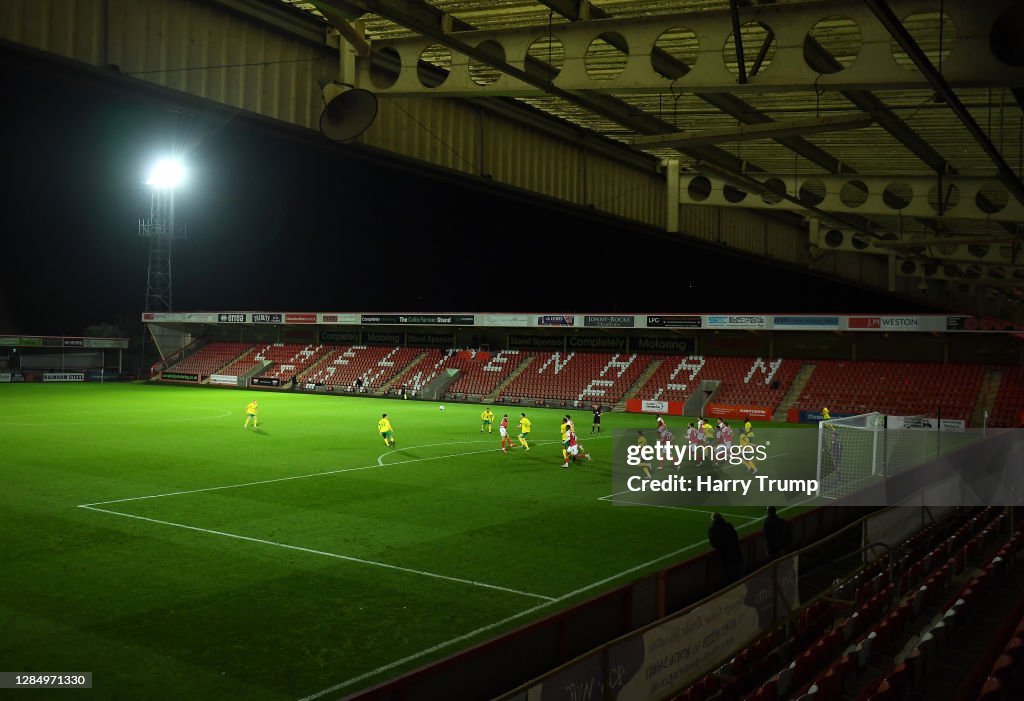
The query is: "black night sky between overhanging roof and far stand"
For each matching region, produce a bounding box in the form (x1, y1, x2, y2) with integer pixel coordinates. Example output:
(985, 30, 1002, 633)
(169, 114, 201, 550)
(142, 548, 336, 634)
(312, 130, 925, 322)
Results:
(0, 47, 937, 335)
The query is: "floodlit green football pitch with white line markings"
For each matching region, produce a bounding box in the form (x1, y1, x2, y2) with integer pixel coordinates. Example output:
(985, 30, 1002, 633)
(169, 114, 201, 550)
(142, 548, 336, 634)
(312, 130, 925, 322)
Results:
(0, 384, 813, 701)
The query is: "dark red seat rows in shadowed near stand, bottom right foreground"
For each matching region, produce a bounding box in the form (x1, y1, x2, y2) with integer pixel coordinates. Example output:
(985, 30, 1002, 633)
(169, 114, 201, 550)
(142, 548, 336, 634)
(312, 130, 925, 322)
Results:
(673, 507, 1024, 701)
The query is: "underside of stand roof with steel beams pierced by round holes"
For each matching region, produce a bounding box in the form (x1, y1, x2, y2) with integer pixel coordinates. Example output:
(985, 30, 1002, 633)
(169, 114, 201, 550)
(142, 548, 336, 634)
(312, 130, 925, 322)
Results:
(280, 0, 1024, 315)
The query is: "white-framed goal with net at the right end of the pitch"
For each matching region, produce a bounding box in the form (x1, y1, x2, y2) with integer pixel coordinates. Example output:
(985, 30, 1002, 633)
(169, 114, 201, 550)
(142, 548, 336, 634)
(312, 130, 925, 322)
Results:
(817, 411, 936, 498)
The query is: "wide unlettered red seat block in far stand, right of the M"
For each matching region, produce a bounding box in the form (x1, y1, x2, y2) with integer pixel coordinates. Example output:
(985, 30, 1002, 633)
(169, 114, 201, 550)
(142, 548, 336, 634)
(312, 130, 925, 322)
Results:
(796, 360, 985, 422)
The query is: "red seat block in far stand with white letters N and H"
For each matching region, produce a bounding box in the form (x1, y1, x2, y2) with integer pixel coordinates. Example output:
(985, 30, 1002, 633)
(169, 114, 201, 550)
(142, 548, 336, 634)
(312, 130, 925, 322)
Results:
(499, 352, 654, 405)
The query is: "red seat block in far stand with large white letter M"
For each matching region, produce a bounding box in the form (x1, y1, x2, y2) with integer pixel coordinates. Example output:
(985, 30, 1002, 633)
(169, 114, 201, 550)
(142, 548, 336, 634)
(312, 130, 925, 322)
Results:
(638, 355, 801, 408)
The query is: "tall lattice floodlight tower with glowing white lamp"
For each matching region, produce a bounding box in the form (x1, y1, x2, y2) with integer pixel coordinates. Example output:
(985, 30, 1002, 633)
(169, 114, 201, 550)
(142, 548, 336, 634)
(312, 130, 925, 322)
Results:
(138, 159, 185, 311)
